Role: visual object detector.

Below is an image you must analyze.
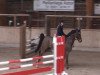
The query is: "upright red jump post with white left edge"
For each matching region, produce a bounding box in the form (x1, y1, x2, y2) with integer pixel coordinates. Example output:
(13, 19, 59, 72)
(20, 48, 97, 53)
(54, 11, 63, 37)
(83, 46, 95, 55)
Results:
(53, 36, 68, 75)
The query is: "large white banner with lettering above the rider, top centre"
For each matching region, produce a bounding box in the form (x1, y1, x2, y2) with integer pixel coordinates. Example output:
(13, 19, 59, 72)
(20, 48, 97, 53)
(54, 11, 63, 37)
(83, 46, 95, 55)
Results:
(33, 0, 75, 11)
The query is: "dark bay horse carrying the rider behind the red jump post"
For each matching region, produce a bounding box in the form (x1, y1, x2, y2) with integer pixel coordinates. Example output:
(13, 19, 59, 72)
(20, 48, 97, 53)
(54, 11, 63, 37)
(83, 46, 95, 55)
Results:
(33, 29, 82, 68)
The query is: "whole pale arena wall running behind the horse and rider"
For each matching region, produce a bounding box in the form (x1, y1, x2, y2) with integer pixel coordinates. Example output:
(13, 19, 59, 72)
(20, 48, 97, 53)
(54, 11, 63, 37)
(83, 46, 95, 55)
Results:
(0, 27, 100, 51)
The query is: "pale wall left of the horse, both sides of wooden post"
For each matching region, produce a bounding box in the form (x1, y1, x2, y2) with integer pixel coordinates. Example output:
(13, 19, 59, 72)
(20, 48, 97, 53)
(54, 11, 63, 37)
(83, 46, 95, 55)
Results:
(0, 27, 44, 47)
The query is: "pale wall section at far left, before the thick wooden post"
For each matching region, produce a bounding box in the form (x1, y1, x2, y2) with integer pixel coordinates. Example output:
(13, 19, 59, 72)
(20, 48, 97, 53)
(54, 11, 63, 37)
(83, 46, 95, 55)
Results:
(0, 27, 19, 46)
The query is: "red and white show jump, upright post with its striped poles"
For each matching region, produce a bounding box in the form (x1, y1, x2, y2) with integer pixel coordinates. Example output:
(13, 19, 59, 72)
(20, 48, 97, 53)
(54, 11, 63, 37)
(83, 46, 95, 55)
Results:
(1, 36, 68, 75)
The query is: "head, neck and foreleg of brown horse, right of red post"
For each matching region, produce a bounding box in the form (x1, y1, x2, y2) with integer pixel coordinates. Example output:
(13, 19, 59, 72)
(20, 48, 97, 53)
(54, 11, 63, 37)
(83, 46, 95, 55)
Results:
(65, 29, 82, 69)
